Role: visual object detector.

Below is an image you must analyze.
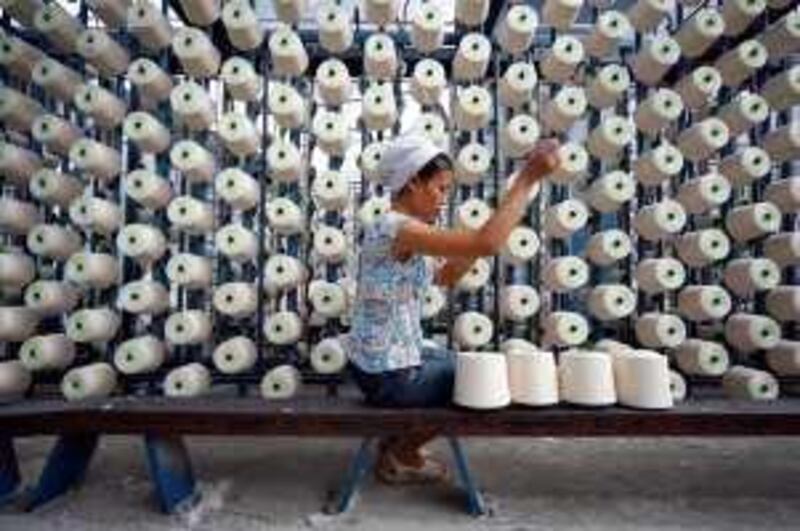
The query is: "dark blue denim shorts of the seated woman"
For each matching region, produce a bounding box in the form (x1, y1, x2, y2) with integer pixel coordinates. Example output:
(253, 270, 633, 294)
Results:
(350, 347, 455, 407)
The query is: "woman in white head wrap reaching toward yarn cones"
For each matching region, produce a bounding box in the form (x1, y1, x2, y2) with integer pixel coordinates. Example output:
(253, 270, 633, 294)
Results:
(347, 135, 559, 483)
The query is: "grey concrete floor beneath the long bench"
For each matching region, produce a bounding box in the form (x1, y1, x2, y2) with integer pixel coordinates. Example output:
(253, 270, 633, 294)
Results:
(0, 437, 800, 531)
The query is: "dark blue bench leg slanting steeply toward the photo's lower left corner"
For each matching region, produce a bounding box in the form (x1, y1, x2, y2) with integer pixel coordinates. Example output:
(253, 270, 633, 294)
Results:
(23, 433, 99, 511)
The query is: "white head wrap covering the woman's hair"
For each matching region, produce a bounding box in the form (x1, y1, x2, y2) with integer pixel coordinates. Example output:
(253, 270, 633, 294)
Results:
(378, 135, 445, 194)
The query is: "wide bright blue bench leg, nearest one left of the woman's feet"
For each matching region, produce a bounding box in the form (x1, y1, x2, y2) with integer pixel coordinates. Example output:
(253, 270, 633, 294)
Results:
(144, 435, 198, 514)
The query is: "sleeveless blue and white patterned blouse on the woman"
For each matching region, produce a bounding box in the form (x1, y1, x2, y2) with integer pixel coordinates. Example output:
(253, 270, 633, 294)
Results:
(347, 211, 433, 373)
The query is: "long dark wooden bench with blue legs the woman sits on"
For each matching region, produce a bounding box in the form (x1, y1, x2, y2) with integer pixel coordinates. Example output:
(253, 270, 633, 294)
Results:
(0, 392, 800, 514)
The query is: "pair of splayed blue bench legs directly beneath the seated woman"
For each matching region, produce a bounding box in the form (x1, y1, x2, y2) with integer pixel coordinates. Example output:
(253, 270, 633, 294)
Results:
(325, 437, 488, 516)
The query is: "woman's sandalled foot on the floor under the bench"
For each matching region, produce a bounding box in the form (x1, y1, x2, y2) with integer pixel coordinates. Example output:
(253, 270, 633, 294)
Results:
(375, 445, 449, 485)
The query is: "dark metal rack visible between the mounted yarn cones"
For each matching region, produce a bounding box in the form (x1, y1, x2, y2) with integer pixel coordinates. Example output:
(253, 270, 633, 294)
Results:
(0, 0, 798, 404)
